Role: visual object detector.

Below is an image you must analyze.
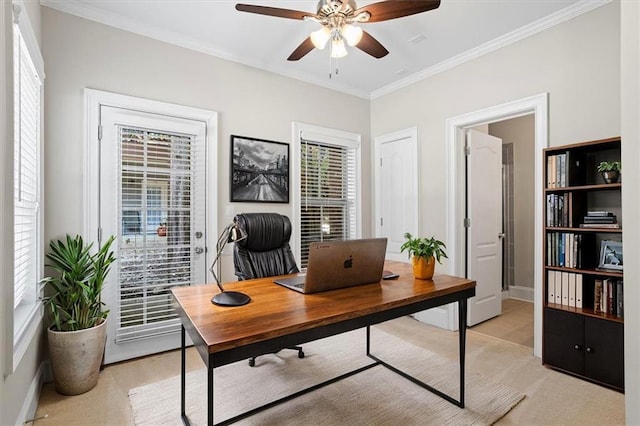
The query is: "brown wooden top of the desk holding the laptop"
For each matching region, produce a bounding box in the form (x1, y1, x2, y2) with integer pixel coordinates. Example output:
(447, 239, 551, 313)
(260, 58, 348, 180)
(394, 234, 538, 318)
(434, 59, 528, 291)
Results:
(171, 262, 476, 353)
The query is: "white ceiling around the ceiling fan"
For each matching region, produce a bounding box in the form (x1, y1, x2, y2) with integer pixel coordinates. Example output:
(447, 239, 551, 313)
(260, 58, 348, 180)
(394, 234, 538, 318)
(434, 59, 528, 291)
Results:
(40, 0, 609, 99)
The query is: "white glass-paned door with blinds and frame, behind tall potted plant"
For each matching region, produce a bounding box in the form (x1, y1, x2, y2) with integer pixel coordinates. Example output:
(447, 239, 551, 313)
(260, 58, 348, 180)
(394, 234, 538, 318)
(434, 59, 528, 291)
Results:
(99, 105, 207, 363)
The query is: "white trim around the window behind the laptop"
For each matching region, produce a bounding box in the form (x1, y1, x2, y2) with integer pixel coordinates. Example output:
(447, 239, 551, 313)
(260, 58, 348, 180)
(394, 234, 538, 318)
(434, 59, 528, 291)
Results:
(289, 122, 362, 259)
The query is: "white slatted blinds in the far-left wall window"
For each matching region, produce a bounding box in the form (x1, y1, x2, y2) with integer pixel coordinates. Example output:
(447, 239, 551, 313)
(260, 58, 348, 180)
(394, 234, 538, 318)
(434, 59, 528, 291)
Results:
(13, 27, 42, 308)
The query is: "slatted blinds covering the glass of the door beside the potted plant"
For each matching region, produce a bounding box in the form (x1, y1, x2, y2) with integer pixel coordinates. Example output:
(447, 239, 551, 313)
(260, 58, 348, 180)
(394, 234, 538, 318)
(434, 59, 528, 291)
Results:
(116, 127, 205, 343)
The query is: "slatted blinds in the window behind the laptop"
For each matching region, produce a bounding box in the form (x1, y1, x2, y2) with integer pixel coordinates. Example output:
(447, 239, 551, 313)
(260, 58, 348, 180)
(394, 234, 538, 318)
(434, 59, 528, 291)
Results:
(300, 139, 357, 268)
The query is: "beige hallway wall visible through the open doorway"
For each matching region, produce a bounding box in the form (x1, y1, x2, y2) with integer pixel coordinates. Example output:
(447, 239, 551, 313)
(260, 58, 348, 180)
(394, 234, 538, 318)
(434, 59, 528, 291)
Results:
(489, 115, 535, 288)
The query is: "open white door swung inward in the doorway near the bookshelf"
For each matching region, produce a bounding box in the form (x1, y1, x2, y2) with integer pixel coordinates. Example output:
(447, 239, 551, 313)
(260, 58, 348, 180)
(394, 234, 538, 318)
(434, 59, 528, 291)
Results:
(467, 130, 502, 326)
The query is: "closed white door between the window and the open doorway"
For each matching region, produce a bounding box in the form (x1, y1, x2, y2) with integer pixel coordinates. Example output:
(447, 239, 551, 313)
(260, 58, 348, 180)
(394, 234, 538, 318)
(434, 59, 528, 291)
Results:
(375, 127, 418, 262)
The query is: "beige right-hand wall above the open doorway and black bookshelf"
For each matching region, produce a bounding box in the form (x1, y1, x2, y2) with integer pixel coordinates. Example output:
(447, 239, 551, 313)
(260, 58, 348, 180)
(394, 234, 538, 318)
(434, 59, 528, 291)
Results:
(371, 2, 620, 245)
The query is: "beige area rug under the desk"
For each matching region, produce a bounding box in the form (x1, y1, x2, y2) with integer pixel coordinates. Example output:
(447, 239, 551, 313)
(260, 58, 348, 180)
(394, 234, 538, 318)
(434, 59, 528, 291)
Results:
(129, 328, 524, 426)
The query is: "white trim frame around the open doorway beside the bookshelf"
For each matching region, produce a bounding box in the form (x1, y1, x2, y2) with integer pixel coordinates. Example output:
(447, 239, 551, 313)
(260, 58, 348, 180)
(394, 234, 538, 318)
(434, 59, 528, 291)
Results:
(446, 93, 548, 357)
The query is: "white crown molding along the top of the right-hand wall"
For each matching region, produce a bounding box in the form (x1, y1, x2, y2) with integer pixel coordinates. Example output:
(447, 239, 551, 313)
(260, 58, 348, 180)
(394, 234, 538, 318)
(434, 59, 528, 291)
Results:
(370, 0, 613, 100)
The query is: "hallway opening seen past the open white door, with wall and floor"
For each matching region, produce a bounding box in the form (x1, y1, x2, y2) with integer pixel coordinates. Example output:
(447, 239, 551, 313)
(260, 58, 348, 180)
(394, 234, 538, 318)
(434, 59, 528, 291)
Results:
(468, 114, 535, 348)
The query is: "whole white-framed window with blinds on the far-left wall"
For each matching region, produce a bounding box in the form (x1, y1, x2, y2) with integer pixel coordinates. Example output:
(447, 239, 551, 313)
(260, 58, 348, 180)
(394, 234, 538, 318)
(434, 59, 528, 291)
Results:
(13, 3, 44, 368)
